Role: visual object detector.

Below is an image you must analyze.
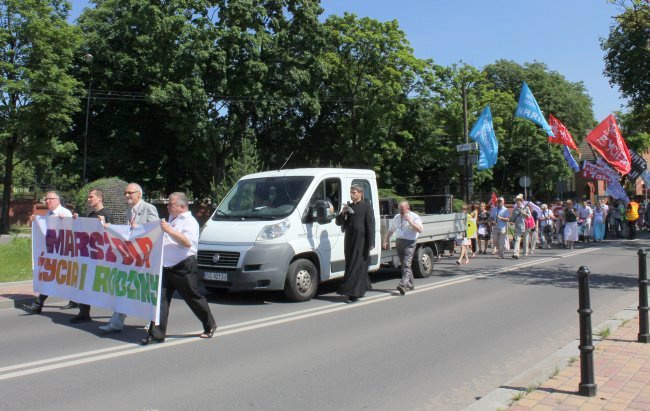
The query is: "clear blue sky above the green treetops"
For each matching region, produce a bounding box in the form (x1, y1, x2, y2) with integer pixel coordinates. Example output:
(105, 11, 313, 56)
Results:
(70, 0, 625, 121)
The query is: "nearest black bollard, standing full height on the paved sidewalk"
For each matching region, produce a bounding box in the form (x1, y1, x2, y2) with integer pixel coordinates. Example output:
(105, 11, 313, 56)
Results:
(578, 266, 596, 397)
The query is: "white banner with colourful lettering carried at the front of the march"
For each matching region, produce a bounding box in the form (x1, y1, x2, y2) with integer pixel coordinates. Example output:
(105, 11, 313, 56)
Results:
(32, 216, 163, 323)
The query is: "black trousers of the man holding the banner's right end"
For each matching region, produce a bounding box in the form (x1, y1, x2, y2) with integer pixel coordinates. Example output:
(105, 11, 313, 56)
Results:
(149, 256, 216, 340)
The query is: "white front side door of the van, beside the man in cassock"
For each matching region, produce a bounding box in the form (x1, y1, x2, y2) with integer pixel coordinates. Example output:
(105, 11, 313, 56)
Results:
(303, 177, 345, 281)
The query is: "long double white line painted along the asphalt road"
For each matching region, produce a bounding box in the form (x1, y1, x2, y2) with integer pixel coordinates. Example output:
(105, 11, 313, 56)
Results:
(0, 248, 600, 381)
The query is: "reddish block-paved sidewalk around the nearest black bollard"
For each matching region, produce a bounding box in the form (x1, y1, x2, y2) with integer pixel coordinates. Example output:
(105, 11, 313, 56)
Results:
(508, 316, 650, 411)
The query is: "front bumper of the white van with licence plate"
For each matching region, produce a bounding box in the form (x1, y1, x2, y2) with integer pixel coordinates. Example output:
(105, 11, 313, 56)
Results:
(198, 244, 295, 291)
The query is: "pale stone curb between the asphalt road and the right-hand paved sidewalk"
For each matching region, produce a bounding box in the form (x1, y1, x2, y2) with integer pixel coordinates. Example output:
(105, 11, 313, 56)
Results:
(463, 306, 639, 411)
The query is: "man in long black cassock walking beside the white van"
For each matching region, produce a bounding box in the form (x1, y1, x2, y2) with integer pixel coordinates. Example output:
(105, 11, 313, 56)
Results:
(336, 185, 375, 301)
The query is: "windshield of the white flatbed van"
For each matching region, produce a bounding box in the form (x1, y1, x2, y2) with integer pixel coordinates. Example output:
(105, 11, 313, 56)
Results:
(212, 176, 314, 220)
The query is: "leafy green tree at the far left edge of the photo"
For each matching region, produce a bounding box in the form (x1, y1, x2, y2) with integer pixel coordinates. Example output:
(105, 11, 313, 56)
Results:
(0, 0, 80, 233)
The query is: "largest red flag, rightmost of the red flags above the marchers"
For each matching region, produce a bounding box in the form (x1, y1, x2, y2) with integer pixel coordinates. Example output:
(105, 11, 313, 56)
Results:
(586, 114, 632, 175)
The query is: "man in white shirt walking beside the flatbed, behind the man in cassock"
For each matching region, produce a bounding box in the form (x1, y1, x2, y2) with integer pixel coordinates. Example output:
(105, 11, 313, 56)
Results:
(384, 201, 423, 295)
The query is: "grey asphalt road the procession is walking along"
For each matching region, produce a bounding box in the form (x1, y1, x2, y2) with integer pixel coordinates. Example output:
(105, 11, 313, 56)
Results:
(0, 239, 650, 410)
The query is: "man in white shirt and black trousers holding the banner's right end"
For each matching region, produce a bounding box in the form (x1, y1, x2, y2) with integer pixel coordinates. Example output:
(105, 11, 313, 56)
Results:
(141, 192, 217, 345)
